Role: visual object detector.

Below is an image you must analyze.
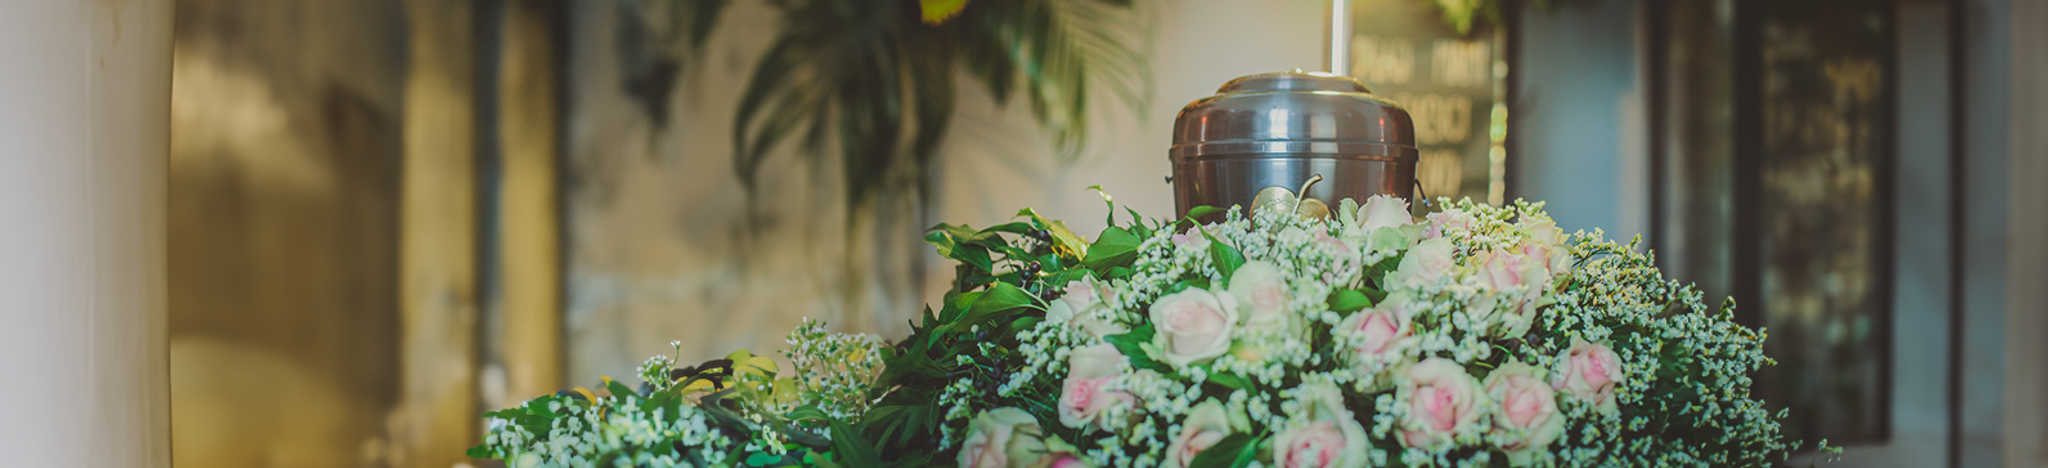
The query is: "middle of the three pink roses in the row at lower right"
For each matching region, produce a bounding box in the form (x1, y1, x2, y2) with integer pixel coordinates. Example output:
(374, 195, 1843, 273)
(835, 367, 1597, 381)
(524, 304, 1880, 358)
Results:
(1487, 362, 1565, 466)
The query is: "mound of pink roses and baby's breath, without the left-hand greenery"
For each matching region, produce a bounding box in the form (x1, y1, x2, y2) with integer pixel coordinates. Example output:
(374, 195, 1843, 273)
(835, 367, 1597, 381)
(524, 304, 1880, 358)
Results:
(940, 196, 1788, 468)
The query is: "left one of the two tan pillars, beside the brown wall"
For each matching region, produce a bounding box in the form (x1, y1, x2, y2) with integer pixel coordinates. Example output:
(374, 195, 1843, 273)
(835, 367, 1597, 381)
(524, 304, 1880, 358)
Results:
(391, 2, 483, 468)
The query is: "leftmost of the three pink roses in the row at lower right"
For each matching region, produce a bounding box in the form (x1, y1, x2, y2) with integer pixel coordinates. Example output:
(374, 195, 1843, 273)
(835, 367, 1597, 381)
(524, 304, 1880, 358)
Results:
(1401, 358, 1487, 450)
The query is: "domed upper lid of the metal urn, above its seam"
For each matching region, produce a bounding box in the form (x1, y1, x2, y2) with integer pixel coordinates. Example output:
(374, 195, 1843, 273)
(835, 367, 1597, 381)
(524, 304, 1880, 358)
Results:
(1167, 69, 1415, 161)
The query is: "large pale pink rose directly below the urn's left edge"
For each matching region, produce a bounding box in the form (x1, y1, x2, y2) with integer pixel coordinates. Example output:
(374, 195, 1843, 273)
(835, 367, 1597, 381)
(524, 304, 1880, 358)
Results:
(1151, 288, 1237, 366)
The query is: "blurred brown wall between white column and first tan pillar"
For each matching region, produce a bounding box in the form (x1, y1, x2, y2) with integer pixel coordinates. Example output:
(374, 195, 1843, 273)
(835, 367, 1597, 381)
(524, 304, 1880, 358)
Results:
(168, 0, 406, 466)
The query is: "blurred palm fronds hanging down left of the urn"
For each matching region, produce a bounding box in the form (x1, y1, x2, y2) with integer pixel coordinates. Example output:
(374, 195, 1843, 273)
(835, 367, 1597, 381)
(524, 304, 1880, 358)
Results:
(733, 0, 1151, 206)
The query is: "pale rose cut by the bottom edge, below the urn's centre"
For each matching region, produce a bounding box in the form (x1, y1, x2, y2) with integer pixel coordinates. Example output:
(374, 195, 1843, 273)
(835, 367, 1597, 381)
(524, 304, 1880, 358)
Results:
(1272, 384, 1370, 468)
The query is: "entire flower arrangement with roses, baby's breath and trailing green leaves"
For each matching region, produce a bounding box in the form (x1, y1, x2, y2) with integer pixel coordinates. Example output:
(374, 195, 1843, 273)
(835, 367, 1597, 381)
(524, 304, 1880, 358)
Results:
(469, 196, 1839, 468)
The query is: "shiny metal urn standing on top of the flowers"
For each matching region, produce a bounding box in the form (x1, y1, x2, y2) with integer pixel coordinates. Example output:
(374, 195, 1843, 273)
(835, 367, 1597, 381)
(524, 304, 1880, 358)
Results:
(1167, 69, 1419, 221)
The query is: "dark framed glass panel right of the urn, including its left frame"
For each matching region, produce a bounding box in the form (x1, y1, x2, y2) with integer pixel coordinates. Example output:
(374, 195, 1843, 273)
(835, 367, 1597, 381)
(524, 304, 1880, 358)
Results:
(1653, 0, 1896, 448)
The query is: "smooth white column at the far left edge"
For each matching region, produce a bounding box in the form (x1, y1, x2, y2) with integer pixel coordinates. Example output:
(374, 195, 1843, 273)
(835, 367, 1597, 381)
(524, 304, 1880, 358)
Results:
(0, 0, 172, 466)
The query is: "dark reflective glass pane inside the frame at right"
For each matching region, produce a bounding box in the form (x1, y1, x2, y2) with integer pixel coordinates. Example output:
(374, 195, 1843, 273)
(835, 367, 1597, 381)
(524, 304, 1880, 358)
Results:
(1759, 2, 1894, 441)
